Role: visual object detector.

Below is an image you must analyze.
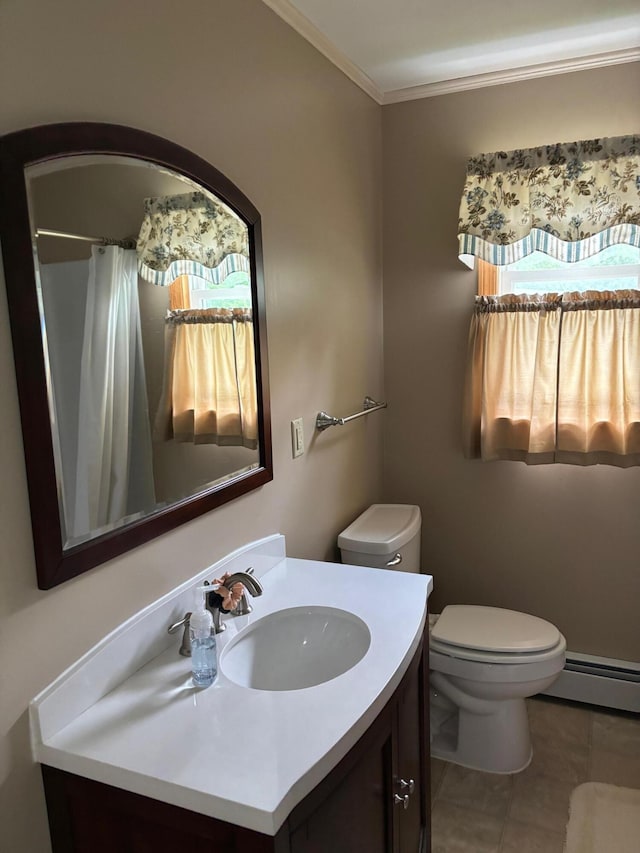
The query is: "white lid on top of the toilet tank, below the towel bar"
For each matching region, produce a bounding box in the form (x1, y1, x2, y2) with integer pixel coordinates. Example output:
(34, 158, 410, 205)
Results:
(338, 504, 422, 554)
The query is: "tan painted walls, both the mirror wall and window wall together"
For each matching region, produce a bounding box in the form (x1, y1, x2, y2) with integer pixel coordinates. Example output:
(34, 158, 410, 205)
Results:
(0, 0, 640, 853)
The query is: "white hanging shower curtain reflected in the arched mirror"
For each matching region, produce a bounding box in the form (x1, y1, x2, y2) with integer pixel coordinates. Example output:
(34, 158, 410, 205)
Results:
(72, 246, 155, 538)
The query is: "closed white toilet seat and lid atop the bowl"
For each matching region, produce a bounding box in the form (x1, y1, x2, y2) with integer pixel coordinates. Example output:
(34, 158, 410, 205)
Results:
(430, 604, 564, 664)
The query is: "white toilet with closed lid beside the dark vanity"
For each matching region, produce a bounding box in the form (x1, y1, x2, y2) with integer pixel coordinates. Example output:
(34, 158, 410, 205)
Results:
(338, 504, 566, 773)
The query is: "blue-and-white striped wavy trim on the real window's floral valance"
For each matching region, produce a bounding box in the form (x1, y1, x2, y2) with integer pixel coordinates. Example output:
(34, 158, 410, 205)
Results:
(458, 223, 640, 269)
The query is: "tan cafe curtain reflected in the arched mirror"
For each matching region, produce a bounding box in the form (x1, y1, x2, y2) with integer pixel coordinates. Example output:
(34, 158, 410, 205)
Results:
(154, 308, 258, 449)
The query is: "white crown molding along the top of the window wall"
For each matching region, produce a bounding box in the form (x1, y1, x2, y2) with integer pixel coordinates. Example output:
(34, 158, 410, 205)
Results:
(382, 47, 640, 104)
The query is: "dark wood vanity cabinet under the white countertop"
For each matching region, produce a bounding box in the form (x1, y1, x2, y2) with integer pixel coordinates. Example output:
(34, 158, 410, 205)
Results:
(42, 628, 431, 853)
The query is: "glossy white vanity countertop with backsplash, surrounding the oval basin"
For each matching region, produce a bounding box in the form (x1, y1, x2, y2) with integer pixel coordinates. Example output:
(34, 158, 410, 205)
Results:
(30, 537, 432, 835)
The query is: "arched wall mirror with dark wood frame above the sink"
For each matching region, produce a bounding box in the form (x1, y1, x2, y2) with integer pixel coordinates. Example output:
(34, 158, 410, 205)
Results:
(0, 123, 273, 589)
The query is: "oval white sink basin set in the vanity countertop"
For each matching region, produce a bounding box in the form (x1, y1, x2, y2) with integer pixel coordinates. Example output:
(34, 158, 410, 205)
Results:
(220, 606, 371, 690)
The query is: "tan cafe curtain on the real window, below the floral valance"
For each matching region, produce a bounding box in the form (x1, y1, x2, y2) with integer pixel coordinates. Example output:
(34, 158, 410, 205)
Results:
(464, 290, 640, 467)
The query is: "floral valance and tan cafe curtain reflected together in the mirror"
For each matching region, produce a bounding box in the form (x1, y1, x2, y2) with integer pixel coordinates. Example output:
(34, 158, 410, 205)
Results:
(146, 192, 258, 450)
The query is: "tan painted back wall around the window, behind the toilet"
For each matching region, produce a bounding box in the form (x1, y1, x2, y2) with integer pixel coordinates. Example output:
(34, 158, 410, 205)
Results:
(383, 63, 640, 661)
